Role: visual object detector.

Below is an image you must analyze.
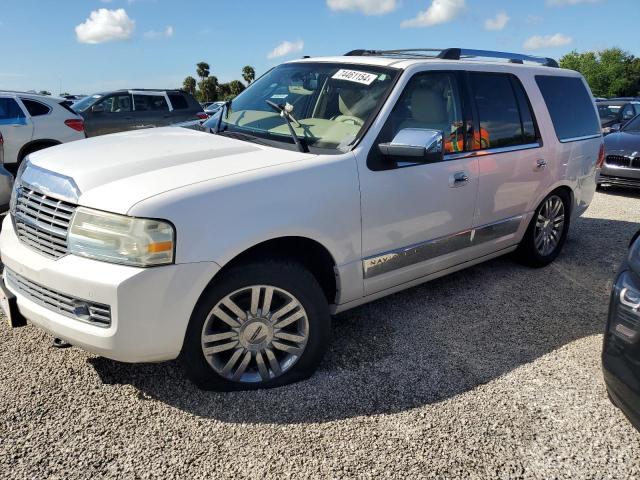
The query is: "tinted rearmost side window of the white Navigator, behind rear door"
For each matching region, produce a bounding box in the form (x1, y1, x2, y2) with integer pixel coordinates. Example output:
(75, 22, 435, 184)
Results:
(536, 75, 600, 141)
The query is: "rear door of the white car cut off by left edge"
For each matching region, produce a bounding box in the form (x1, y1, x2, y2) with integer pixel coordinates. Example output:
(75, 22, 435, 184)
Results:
(0, 95, 33, 163)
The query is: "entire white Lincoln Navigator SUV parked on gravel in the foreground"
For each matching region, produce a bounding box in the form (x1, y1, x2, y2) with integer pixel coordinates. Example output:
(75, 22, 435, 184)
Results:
(0, 49, 603, 390)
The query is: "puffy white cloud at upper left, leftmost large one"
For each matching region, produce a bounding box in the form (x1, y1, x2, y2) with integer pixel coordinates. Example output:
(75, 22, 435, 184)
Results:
(76, 8, 136, 43)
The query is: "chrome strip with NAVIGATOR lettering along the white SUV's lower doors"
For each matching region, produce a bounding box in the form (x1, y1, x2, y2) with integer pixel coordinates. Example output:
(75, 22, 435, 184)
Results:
(362, 215, 524, 280)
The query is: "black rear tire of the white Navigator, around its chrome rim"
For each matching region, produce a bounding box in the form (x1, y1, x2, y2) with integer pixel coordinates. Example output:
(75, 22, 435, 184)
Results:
(515, 190, 571, 268)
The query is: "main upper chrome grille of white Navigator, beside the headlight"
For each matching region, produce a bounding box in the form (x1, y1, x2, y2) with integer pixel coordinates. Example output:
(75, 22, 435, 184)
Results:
(12, 185, 76, 258)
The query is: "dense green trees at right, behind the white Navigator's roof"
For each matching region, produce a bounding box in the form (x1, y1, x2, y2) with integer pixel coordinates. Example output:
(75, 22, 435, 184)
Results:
(560, 48, 640, 97)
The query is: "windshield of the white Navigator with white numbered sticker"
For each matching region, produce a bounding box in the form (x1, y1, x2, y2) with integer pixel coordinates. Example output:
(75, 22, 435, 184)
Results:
(216, 63, 398, 151)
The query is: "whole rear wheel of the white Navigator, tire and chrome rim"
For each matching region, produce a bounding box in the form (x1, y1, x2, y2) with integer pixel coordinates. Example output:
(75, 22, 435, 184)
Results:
(516, 192, 570, 267)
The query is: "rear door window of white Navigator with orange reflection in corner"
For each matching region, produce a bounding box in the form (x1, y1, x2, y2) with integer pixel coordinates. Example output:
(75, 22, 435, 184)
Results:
(469, 73, 535, 150)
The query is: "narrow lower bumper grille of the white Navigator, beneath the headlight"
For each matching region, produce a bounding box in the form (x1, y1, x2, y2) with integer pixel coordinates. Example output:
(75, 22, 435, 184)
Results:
(5, 268, 111, 327)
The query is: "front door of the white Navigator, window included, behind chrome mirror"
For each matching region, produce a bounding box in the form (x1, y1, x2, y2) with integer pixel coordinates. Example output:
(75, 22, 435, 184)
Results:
(359, 72, 478, 295)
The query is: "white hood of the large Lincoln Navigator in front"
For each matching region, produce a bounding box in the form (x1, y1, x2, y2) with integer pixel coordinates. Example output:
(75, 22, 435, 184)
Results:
(29, 127, 314, 213)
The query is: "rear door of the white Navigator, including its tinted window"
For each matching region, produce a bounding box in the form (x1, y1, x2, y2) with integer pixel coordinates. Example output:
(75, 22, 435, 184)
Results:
(468, 72, 557, 256)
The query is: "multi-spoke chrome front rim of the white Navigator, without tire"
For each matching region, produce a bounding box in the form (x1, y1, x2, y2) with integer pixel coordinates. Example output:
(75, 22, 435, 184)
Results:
(201, 285, 309, 383)
